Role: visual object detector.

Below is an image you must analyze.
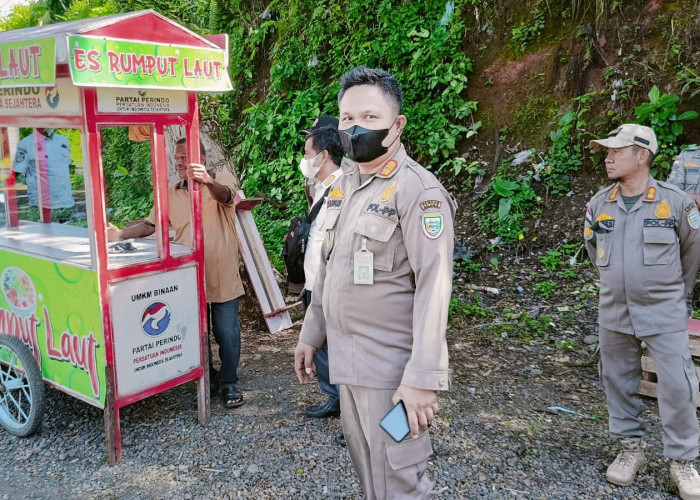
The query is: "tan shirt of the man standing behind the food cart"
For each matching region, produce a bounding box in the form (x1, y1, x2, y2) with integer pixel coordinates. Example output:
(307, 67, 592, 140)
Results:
(146, 172, 244, 302)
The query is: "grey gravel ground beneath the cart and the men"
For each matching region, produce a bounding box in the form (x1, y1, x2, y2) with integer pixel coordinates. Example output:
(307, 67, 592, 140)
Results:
(0, 318, 688, 500)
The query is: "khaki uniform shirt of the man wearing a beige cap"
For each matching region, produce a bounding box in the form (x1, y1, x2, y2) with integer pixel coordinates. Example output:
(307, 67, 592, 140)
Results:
(584, 177, 700, 336)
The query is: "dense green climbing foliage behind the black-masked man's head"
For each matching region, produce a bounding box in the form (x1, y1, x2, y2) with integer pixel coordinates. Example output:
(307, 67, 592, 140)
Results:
(202, 0, 481, 266)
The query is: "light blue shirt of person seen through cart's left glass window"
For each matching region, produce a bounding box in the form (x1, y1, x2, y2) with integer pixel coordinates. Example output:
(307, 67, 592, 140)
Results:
(14, 128, 75, 210)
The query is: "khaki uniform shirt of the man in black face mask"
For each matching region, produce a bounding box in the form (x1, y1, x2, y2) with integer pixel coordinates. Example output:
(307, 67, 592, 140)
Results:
(300, 147, 456, 390)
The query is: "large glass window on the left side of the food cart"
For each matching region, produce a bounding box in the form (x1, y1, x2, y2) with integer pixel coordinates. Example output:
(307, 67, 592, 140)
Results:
(0, 128, 92, 267)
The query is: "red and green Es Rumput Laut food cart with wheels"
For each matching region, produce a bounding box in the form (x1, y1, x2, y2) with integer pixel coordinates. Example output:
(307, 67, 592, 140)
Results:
(0, 10, 231, 465)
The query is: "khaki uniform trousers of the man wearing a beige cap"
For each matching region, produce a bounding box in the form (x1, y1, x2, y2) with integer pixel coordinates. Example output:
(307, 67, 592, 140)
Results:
(599, 327, 700, 460)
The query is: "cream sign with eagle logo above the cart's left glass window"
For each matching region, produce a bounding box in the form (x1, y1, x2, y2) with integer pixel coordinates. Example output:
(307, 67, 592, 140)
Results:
(0, 78, 80, 116)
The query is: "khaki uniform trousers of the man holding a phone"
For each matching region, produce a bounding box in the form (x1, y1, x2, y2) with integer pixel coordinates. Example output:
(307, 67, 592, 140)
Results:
(340, 385, 433, 500)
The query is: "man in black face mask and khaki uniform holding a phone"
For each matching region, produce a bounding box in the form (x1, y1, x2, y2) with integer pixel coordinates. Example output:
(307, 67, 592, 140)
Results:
(294, 67, 456, 500)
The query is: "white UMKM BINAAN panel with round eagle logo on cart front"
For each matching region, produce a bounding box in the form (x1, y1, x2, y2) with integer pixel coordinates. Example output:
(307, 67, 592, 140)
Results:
(110, 267, 201, 396)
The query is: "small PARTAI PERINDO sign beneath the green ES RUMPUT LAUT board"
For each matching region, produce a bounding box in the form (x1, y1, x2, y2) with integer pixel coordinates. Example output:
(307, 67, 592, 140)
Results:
(97, 88, 187, 114)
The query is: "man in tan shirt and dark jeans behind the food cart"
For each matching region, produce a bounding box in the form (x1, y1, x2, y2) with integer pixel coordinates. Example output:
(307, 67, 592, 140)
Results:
(107, 138, 244, 408)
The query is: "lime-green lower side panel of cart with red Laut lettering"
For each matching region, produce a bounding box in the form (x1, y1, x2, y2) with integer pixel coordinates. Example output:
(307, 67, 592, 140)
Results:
(0, 250, 106, 408)
